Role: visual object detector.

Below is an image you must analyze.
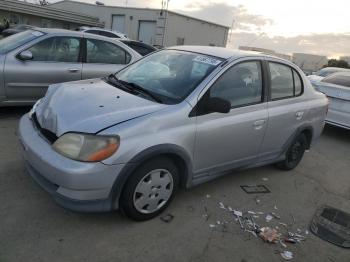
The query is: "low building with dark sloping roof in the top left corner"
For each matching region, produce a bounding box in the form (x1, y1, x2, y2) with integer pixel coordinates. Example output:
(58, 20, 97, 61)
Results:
(0, 0, 103, 29)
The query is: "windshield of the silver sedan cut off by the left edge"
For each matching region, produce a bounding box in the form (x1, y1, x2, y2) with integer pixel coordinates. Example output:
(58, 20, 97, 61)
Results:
(0, 30, 44, 54)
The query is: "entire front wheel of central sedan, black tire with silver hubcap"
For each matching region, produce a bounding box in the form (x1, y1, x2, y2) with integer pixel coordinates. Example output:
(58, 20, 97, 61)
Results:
(120, 157, 179, 221)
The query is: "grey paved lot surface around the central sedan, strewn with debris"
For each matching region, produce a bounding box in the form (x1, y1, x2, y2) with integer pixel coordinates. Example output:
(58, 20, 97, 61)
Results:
(0, 108, 350, 262)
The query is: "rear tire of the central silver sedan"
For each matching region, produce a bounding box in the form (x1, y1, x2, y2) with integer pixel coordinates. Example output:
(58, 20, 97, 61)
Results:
(276, 134, 307, 171)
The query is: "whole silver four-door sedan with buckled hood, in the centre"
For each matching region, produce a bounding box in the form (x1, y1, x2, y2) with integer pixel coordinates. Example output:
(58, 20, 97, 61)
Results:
(19, 46, 328, 220)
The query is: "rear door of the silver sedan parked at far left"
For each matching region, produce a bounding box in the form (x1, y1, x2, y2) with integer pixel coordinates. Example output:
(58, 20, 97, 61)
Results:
(82, 38, 131, 79)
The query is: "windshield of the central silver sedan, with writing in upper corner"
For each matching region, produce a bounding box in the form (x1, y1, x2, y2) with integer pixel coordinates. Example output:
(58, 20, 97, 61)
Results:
(116, 50, 223, 104)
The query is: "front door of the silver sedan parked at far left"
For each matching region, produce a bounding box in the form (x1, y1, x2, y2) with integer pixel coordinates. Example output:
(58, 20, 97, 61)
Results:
(4, 36, 82, 102)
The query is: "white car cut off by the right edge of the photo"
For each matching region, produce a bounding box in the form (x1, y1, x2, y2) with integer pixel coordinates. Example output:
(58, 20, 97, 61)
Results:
(312, 70, 350, 129)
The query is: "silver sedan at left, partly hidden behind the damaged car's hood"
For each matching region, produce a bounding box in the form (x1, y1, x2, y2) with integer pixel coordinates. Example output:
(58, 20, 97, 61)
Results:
(0, 29, 141, 106)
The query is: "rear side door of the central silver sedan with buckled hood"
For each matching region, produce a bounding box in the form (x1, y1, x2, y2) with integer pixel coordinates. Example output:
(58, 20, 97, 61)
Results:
(261, 61, 308, 161)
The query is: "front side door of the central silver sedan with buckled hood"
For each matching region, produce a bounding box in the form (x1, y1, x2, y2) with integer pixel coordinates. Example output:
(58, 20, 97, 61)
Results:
(194, 60, 268, 173)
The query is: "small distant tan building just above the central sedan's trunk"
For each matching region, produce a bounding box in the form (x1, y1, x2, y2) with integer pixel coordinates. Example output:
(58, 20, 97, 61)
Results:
(292, 53, 328, 74)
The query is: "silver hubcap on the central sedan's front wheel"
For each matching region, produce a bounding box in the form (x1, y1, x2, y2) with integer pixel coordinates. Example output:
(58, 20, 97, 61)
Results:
(133, 169, 174, 214)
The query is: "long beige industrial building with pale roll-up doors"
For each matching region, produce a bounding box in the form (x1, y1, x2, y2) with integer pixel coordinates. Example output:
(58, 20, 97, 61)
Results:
(49, 0, 230, 46)
